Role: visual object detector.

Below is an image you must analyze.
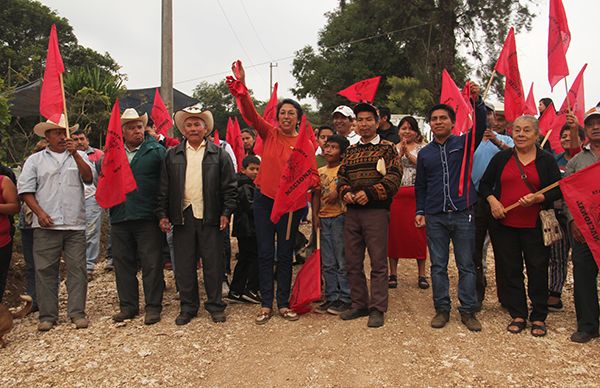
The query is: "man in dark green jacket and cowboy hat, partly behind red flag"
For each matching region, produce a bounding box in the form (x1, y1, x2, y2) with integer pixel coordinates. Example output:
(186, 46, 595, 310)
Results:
(110, 108, 165, 325)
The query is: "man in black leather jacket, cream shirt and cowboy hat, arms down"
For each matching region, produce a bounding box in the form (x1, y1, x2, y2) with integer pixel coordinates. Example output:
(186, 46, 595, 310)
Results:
(157, 105, 237, 325)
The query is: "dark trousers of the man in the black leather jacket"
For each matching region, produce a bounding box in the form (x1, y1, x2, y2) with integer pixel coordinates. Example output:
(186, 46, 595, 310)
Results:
(173, 206, 226, 315)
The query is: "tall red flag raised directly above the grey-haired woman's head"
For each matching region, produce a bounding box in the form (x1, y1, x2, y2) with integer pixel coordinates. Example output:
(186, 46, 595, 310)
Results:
(494, 27, 525, 122)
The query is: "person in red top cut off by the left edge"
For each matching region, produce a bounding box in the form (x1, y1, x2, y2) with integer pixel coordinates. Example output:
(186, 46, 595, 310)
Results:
(0, 175, 20, 302)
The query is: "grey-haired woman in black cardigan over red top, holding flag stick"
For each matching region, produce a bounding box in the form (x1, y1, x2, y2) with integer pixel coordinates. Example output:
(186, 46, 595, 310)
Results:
(479, 116, 562, 337)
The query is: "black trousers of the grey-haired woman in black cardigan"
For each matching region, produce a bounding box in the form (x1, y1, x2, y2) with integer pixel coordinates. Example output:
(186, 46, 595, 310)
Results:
(490, 220, 548, 321)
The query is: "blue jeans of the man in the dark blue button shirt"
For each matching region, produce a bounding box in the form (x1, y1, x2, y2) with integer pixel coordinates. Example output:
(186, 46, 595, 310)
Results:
(425, 210, 478, 313)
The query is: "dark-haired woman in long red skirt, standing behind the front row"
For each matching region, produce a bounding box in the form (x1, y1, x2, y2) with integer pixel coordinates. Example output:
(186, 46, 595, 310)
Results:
(388, 116, 429, 289)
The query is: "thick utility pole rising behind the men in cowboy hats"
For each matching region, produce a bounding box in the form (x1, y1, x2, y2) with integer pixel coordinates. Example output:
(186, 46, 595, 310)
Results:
(160, 0, 173, 135)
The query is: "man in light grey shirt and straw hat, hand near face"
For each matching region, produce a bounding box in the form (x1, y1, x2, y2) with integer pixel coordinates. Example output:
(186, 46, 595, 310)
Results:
(17, 116, 94, 331)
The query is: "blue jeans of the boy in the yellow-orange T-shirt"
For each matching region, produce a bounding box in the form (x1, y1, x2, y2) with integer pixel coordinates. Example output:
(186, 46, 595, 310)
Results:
(320, 214, 350, 303)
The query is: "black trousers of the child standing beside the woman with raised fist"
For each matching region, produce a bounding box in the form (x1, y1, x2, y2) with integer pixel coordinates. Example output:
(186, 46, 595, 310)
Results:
(230, 236, 258, 294)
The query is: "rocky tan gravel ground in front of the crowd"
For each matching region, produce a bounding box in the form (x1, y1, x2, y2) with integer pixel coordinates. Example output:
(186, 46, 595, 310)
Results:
(0, 223, 600, 387)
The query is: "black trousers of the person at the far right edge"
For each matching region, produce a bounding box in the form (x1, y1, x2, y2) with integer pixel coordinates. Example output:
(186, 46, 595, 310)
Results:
(573, 241, 600, 334)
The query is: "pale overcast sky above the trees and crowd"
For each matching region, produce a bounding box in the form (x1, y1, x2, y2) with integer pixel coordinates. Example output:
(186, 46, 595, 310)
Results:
(41, 0, 600, 112)
